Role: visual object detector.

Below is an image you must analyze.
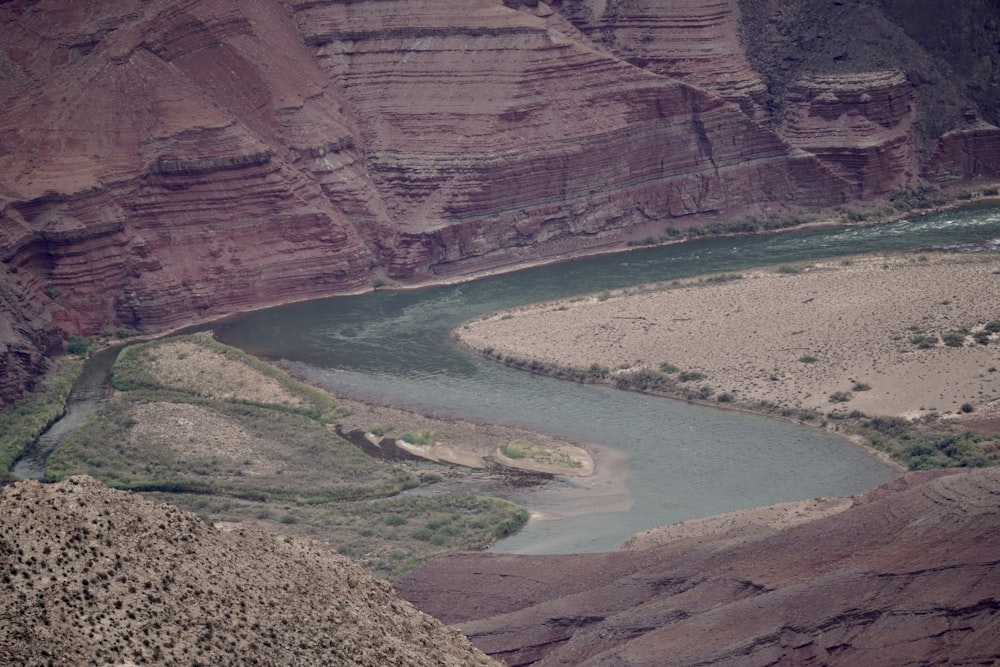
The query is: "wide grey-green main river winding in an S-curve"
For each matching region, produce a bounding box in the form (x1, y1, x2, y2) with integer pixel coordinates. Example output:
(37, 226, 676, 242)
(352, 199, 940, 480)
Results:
(201, 207, 1000, 553)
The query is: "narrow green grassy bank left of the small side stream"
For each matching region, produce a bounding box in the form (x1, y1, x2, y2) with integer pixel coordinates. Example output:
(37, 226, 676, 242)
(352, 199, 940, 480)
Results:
(0, 358, 83, 480)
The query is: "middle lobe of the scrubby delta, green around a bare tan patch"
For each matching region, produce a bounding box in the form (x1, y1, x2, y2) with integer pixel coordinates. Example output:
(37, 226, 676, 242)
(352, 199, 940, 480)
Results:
(46, 390, 419, 502)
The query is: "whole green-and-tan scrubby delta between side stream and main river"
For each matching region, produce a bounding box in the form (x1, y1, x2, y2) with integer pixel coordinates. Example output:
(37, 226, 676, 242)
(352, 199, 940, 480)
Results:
(45, 334, 528, 578)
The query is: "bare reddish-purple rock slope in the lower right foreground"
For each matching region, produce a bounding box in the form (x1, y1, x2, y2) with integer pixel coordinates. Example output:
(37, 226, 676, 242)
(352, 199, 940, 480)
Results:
(397, 469, 1000, 666)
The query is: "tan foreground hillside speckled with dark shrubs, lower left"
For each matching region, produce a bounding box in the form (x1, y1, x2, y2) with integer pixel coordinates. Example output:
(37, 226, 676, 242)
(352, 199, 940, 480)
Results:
(0, 477, 496, 667)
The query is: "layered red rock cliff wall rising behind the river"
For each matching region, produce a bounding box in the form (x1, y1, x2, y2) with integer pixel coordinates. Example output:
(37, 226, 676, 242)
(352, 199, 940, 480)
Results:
(0, 0, 1000, 402)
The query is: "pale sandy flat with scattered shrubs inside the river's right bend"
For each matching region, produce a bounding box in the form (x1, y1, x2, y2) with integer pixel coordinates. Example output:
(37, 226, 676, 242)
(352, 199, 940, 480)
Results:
(455, 253, 1000, 418)
